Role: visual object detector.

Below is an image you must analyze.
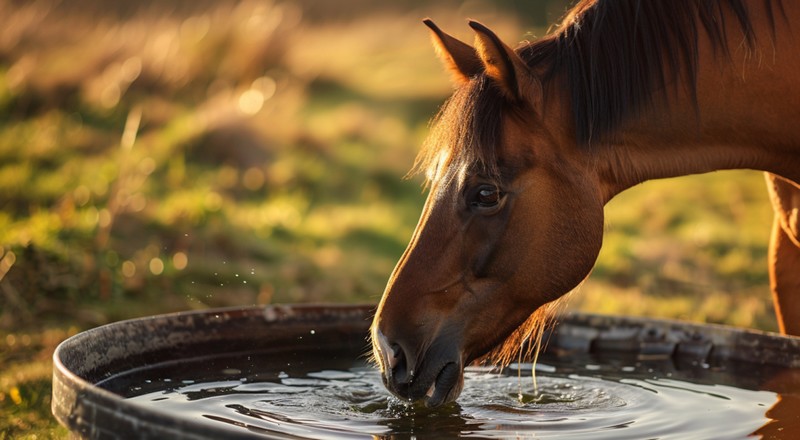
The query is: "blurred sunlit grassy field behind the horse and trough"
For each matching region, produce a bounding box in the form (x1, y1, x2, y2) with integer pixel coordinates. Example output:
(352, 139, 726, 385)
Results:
(0, 0, 776, 440)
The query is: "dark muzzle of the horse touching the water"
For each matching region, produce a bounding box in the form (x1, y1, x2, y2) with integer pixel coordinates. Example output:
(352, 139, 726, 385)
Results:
(372, 328, 464, 407)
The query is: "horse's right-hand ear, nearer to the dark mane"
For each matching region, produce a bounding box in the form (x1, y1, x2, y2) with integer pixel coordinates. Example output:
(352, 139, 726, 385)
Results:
(469, 20, 538, 101)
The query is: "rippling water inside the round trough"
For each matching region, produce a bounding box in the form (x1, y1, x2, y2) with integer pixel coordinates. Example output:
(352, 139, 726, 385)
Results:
(100, 353, 800, 439)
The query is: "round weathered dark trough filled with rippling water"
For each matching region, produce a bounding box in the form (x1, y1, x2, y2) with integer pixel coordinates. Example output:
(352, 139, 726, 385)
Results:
(52, 305, 800, 439)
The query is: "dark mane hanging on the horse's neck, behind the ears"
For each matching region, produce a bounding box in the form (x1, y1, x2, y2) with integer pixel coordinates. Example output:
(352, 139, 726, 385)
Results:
(517, 0, 783, 145)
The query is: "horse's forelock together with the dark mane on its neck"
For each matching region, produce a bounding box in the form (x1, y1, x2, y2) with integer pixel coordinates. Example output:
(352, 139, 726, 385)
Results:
(422, 0, 786, 181)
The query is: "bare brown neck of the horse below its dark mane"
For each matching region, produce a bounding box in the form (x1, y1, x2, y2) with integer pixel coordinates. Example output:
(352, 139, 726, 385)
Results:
(588, 2, 800, 201)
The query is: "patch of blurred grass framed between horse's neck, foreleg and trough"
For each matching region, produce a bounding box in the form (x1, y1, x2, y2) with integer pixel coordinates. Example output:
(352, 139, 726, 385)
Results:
(570, 171, 777, 331)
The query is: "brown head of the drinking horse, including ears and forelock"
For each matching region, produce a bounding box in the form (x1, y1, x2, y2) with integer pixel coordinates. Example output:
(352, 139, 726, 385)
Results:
(371, 20, 604, 406)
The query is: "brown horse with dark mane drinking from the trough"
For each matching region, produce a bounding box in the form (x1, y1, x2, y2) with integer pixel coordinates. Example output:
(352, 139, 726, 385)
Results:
(372, 0, 800, 406)
